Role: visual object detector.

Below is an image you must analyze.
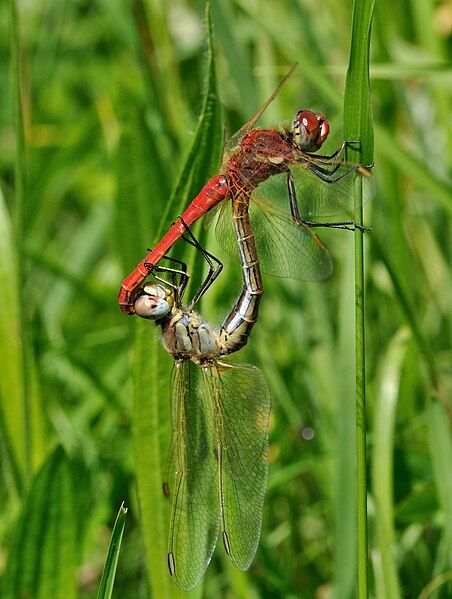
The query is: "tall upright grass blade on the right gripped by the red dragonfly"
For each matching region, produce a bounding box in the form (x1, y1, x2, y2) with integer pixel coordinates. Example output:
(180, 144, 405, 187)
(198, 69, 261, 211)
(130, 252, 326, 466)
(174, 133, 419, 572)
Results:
(344, 0, 374, 599)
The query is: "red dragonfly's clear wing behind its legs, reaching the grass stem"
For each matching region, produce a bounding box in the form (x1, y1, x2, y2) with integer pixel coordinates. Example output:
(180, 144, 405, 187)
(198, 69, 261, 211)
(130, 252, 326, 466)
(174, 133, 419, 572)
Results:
(288, 162, 376, 220)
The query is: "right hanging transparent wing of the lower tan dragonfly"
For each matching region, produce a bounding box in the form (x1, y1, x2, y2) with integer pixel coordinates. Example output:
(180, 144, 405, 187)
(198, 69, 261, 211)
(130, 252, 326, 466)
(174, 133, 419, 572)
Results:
(211, 362, 270, 570)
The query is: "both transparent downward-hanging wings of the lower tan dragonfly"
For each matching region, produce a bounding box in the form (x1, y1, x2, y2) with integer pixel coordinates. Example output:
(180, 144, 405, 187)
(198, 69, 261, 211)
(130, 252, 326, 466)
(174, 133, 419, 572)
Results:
(168, 361, 270, 591)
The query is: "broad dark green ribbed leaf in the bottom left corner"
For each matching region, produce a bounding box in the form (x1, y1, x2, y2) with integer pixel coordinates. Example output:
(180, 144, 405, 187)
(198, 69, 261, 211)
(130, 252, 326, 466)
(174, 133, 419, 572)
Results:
(1, 447, 79, 599)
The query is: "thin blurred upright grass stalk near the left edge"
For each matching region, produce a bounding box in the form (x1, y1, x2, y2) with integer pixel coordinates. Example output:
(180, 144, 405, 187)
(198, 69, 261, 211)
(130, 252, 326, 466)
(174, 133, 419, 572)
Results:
(10, 0, 31, 480)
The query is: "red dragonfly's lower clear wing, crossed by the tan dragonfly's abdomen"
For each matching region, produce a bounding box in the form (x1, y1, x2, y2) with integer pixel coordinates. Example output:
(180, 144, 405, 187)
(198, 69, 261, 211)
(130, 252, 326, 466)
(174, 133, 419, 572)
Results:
(215, 185, 333, 281)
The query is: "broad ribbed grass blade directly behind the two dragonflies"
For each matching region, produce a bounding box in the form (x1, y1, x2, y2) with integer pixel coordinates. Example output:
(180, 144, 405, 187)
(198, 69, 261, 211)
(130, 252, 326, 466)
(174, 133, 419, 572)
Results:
(132, 3, 221, 598)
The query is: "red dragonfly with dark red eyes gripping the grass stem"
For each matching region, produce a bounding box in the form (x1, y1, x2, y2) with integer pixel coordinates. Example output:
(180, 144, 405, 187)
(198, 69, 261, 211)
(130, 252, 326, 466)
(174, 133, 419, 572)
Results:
(118, 67, 375, 314)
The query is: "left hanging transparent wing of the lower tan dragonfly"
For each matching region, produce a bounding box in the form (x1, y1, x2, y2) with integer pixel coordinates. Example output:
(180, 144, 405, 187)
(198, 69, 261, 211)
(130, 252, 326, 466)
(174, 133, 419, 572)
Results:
(168, 361, 220, 591)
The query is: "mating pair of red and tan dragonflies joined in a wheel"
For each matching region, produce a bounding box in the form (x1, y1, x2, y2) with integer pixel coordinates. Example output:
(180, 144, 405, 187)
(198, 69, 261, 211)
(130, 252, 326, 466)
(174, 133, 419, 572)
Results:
(118, 71, 375, 590)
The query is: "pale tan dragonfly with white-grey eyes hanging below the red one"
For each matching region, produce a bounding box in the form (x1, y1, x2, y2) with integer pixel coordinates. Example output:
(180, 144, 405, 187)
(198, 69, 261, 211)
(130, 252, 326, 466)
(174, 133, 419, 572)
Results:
(134, 224, 270, 591)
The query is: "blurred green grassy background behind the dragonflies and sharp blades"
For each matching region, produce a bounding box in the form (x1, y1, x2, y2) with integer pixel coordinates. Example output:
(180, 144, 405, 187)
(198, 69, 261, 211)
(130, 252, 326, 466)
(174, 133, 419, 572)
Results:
(0, 0, 452, 599)
